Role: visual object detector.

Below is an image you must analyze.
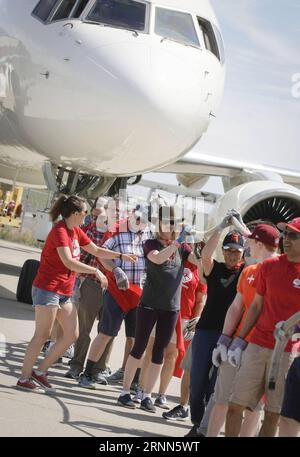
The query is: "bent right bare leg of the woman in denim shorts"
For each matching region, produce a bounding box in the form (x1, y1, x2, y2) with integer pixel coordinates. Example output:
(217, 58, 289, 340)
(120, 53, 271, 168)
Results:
(39, 303, 79, 372)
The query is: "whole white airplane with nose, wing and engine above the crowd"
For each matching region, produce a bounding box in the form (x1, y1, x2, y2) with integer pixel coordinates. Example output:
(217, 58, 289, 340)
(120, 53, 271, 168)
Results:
(0, 0, 300, 221)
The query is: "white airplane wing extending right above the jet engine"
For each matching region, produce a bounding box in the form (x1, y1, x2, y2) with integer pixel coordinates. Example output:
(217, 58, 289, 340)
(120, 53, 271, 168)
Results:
(159, 151, 300, 187)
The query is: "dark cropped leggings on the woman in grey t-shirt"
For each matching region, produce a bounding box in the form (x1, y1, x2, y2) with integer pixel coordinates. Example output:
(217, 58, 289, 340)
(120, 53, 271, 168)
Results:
(130, 307, 178, 364)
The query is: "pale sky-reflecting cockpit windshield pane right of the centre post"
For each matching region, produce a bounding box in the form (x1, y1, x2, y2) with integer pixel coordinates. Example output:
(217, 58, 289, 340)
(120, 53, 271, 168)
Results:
(155, 7, 200, 47)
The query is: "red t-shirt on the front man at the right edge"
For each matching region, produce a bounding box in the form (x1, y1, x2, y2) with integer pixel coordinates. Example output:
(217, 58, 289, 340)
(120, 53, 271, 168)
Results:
(250, 254, 300, 352)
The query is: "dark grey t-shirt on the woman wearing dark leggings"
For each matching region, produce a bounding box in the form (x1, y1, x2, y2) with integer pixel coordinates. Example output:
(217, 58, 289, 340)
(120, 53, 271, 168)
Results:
(140, 240, 191, 311)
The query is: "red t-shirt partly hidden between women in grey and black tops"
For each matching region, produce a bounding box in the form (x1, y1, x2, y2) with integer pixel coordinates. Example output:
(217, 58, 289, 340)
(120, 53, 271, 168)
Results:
(180, 261, 207, 319)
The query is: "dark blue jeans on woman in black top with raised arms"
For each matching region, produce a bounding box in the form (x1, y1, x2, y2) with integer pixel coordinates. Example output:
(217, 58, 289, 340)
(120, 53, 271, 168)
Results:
(190, 329, 221, 425)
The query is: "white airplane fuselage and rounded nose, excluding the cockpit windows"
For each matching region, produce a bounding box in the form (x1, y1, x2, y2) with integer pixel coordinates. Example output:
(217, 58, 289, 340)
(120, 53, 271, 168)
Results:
(0, 0, 225, 183)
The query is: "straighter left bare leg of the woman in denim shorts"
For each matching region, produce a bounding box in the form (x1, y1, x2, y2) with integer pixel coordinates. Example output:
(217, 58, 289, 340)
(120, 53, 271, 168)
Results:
(22, 306, 58, 379)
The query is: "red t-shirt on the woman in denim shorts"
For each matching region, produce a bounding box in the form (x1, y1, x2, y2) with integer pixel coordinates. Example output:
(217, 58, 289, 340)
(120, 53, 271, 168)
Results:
(33, 221, 91, 297)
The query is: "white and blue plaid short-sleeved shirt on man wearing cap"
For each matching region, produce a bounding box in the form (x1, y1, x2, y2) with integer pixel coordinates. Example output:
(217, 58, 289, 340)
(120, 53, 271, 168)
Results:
(103, 228, 153, 288)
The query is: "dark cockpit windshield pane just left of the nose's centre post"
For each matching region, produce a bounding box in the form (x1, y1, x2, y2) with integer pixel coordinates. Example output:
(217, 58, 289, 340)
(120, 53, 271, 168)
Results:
(86, 0, 146, 31)
